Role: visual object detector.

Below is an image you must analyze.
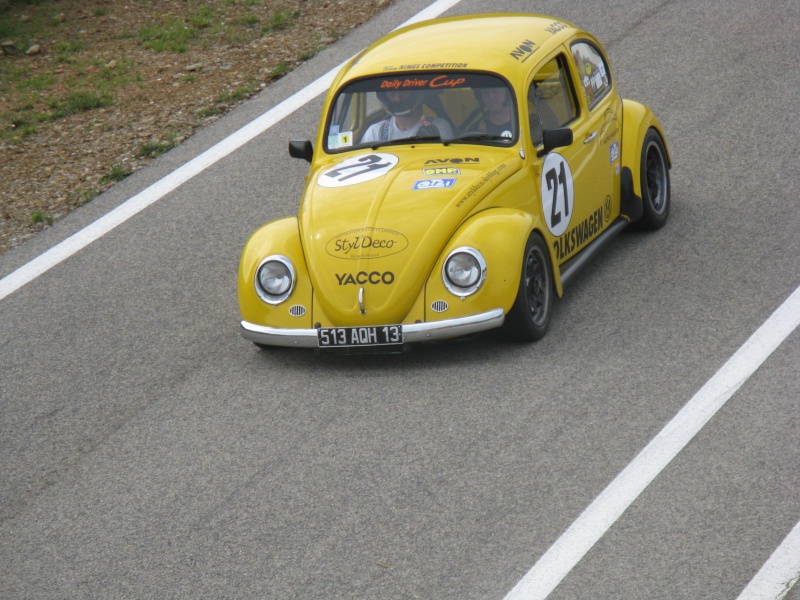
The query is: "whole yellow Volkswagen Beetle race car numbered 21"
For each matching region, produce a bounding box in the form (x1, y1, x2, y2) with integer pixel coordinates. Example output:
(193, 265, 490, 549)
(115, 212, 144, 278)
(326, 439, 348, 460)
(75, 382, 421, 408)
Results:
(238, 14, 670, 353)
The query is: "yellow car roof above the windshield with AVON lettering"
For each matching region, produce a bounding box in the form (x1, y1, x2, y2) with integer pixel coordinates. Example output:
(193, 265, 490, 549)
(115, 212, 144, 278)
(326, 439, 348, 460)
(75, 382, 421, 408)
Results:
(341, 13, 583, 80)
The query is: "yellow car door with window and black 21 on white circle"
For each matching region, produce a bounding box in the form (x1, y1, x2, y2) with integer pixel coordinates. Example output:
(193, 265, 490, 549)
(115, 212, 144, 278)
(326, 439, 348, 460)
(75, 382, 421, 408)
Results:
(528, 49, 618, 263)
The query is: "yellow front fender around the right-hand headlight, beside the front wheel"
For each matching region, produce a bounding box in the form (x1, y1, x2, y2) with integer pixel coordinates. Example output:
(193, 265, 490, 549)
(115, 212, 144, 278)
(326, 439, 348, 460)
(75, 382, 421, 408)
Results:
(424, 208, 539, 322)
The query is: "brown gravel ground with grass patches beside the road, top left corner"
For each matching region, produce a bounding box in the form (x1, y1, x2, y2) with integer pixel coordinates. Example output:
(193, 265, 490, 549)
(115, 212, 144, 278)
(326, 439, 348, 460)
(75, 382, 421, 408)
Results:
(0, 0, 391, 254)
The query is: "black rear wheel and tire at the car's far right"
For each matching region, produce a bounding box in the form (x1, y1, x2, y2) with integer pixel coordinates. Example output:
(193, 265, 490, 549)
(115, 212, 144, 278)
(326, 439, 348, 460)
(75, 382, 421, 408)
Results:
(639, 129, 670, 230)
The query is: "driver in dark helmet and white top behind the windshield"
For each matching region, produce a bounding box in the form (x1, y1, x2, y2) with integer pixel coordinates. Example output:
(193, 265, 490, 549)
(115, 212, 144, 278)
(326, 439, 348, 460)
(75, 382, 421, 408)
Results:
(361, 90, 453, 143)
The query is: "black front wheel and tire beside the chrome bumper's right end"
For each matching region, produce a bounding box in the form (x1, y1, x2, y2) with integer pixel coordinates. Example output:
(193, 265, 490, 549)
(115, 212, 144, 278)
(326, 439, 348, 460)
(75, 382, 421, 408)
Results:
(504, 231, 555, 342)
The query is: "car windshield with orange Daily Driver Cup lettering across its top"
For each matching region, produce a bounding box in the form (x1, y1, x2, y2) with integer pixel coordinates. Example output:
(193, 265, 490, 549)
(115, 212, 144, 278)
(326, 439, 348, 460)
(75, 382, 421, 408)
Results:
(325, 71, 518, 152)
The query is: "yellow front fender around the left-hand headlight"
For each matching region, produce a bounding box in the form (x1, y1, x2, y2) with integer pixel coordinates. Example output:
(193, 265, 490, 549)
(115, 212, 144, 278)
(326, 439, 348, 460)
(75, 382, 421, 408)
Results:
(238, 217, 313, 328)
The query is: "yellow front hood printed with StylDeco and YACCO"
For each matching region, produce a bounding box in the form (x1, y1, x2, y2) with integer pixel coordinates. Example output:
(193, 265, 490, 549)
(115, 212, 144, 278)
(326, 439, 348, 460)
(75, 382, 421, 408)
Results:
(299, 147, 522, 326)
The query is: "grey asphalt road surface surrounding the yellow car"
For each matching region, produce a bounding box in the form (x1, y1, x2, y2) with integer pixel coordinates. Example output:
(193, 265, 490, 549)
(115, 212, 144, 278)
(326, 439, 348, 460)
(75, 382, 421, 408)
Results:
(0, 0, 800, 599)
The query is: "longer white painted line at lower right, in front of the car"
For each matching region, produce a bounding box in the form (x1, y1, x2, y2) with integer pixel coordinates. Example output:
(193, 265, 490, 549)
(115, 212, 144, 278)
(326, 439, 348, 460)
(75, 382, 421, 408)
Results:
(505, 287, 800, 600)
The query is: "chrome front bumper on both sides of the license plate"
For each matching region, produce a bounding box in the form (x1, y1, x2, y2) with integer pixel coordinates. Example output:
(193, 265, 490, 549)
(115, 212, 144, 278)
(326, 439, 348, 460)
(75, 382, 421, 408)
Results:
(241, 308, 505, 348)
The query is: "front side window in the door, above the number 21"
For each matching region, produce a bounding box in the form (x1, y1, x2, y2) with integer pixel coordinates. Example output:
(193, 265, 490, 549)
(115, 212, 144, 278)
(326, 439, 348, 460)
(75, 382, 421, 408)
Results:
(528, 55, 578, 145)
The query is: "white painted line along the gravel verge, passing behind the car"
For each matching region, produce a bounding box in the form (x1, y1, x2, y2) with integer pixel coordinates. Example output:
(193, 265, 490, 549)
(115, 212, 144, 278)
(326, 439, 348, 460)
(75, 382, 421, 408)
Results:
(0, 0, 461, 300)
